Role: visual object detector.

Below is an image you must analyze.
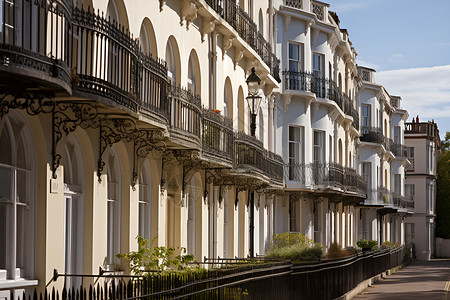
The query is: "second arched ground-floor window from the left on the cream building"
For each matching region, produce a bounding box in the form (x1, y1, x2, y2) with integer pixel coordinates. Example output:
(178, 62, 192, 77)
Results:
(62, 134, 85, 288)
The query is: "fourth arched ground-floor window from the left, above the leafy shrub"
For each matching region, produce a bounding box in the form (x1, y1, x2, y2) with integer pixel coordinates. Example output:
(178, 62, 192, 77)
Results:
(138, 160, 153, 241)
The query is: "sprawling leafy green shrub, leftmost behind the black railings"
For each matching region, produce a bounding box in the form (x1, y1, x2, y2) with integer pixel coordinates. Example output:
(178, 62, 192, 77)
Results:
(117, 235, 194, 275)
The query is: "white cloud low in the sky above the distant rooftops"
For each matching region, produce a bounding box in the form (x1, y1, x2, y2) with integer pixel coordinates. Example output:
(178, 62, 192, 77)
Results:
(376, 65, 450, 132)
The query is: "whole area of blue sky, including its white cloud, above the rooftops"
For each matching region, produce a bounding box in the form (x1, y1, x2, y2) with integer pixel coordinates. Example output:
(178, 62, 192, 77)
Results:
(327, 0, 450, 138)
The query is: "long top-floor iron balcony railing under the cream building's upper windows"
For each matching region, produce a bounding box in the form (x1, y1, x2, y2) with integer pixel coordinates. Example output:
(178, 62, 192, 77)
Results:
(206, 0, 281, 82)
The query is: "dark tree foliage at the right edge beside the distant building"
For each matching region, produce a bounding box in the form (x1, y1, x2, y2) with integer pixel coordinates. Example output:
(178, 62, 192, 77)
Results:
(436, 150, 450, 239)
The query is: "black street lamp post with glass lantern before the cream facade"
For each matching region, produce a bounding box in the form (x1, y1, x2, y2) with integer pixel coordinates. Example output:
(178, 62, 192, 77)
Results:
(246, 68, 261, 257)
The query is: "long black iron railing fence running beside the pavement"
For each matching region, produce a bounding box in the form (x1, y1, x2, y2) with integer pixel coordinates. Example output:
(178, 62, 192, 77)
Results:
(23, 247, 405, 300)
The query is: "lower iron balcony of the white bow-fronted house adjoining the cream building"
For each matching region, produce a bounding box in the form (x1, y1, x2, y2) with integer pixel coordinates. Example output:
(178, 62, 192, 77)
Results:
(285, 162, 367, 197)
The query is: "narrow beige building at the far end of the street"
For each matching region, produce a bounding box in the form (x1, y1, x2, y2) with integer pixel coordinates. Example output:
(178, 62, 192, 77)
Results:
(405, 117, 441, 260)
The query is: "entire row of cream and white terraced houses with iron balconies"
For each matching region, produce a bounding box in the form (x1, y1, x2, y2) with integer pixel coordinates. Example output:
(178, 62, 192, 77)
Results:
(0, 0, 426, 299)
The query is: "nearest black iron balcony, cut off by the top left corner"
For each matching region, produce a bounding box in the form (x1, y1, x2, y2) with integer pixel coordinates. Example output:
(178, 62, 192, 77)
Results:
(0, 0, 72, 92)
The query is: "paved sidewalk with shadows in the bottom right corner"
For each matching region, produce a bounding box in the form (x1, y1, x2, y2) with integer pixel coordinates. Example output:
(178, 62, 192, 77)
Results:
(353, 259, 450, 300)
